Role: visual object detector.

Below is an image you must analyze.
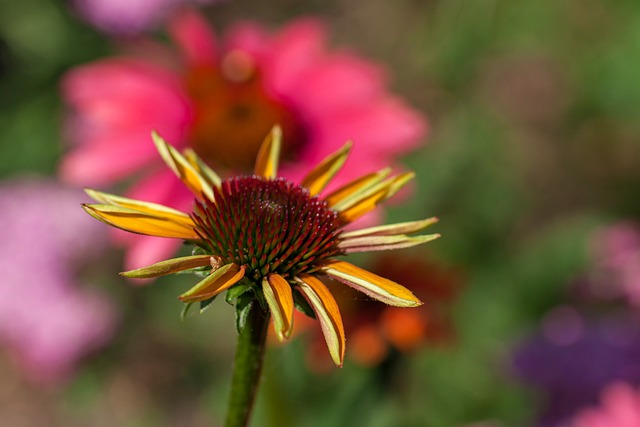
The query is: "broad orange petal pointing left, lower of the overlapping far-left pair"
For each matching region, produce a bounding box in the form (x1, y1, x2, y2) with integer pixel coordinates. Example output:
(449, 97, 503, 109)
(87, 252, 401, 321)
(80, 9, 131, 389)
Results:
(82, 205, 200, 240)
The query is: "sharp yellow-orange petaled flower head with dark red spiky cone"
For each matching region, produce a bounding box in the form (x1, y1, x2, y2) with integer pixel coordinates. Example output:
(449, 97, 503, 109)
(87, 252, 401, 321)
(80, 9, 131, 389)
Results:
(84, 128, 439, 365)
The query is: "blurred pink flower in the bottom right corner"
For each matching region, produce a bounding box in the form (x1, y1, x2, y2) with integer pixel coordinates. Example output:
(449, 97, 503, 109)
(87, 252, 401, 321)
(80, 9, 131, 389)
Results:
(570, 382, 640, 427)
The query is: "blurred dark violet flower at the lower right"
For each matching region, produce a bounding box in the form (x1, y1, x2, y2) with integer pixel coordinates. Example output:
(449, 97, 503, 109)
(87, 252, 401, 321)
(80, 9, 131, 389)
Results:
(514, 306, 640, 427)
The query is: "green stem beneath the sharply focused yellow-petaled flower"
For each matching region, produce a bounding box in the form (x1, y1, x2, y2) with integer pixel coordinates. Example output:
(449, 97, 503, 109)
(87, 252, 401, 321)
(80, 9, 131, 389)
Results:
(224, 302, 269, 427)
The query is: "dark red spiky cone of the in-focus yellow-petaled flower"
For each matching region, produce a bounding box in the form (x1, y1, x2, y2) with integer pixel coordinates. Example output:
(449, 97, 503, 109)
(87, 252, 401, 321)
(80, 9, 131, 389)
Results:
(192, 176, 341, 281)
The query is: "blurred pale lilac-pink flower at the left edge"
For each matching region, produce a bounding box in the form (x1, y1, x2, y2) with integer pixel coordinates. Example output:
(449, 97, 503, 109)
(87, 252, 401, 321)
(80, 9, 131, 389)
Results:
(0, 179, 116, 382)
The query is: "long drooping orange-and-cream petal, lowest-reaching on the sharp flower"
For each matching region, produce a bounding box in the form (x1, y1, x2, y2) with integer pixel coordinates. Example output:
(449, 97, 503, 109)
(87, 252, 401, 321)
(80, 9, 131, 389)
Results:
(296, 274, 346, 366)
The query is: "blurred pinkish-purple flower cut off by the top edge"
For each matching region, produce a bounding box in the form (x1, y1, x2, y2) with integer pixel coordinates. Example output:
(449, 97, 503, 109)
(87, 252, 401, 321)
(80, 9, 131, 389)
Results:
(73, 0, 217, 35)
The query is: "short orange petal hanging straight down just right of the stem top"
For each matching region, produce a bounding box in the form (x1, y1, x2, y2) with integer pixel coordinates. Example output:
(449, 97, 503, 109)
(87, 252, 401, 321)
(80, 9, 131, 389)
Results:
(262, 274, 293, 341)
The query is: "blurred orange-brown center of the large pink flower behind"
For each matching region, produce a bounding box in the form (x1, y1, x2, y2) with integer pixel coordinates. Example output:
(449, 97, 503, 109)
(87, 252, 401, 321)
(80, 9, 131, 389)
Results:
(186, 50, 305, 171)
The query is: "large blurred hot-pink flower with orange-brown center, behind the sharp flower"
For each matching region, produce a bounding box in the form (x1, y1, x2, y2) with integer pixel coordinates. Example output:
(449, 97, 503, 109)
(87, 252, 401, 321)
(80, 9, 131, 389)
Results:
(60, 12, 426, 269)
